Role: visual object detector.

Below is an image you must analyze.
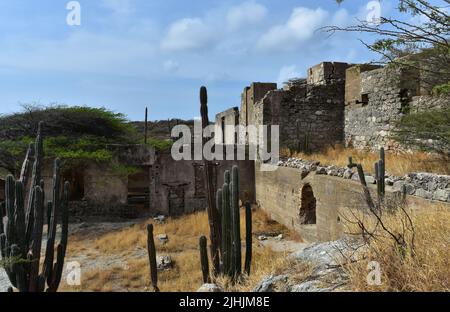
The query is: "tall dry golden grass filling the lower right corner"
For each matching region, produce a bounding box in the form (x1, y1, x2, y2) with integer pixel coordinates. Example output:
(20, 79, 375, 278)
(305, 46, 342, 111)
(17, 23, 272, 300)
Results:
(347, 207, 450, 291)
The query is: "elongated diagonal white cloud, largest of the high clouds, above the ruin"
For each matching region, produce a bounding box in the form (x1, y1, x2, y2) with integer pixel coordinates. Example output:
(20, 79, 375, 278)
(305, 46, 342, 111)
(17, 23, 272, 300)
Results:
(258, 7, 329, 50)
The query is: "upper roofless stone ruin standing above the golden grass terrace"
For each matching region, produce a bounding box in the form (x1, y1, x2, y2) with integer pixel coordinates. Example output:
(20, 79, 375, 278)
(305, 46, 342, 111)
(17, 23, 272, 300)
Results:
(216, 62, 450, 152)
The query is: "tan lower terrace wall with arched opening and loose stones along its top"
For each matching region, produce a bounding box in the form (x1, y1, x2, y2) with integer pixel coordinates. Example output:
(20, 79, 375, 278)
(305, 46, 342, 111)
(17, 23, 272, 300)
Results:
(255, 162, 450, 242)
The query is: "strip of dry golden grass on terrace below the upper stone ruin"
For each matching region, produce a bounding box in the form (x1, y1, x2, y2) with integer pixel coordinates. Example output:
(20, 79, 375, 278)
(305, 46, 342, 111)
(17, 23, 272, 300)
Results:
(281, 146, 450, 176)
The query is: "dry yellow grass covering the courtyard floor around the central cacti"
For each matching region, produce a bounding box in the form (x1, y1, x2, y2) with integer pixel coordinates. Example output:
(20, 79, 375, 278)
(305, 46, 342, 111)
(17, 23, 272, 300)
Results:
(61, 210, 297, 292)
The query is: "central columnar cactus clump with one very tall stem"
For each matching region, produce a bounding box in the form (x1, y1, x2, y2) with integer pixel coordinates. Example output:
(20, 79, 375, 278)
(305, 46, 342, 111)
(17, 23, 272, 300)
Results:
(199, 87, 252, 282)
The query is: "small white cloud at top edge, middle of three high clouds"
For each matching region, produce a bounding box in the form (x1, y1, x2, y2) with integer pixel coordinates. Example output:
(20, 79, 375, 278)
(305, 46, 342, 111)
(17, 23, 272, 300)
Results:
(226, 1, 267, 31)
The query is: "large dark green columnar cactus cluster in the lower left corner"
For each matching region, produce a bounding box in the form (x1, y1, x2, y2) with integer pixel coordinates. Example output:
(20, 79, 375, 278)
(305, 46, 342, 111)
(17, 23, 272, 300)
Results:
(0, 123, 69, 292)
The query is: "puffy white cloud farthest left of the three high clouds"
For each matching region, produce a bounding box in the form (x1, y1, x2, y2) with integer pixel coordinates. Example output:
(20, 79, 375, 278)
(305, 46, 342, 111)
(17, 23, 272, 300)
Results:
(161, 18, 214, 51)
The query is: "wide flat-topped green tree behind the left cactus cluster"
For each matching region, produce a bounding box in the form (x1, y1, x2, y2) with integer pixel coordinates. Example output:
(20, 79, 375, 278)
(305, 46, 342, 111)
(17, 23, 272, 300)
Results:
(0, 105, 137, 172)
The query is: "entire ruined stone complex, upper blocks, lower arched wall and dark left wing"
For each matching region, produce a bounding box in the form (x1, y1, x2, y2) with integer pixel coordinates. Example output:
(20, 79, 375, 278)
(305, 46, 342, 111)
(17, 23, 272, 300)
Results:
(0, 62, 450, 241)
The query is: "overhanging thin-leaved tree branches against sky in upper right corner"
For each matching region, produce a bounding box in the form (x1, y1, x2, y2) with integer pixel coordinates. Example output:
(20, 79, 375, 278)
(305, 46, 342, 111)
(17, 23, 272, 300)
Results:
(323, 0, 450, 90)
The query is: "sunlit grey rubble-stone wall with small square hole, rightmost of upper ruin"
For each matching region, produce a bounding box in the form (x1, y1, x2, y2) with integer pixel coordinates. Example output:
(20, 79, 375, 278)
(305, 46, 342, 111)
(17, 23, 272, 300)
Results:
(344, 65, 450, 150)
